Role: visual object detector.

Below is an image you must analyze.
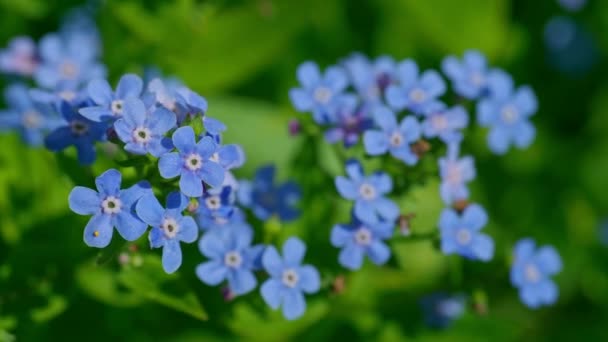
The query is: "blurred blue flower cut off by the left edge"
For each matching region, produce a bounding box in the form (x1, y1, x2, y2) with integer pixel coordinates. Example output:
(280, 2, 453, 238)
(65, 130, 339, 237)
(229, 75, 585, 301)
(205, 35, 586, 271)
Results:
(0, 84, 61, 146)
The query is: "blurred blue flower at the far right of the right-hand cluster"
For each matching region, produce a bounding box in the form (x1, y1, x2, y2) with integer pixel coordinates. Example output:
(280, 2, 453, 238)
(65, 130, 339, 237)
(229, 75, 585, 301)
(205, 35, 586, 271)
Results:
(477, 71, 538, 154)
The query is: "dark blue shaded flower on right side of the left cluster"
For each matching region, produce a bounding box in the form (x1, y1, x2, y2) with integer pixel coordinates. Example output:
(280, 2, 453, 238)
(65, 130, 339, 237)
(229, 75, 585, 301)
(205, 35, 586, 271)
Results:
(238, 165, 301, 222)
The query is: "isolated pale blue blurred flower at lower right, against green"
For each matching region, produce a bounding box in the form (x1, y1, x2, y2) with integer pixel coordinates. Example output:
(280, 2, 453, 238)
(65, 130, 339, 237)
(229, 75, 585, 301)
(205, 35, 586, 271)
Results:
(511, 238, 562, 309)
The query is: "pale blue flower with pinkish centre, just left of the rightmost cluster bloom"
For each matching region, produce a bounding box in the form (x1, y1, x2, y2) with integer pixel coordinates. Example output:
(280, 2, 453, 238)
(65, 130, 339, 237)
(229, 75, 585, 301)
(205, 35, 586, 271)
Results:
(422, 102, 469, 143)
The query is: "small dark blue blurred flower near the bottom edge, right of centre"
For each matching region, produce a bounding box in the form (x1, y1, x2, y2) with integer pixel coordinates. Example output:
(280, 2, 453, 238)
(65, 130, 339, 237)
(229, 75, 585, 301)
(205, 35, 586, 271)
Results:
(420, 292, 466, 329)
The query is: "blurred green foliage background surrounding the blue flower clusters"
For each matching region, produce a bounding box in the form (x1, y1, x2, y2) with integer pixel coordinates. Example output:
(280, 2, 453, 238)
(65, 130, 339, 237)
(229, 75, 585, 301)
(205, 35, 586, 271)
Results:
(0, 0, 608, 341)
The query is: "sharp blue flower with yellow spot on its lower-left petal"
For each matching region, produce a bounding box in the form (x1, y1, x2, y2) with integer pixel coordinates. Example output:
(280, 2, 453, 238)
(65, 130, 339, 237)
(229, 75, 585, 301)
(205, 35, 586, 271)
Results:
(69, 169, 152, 248)
